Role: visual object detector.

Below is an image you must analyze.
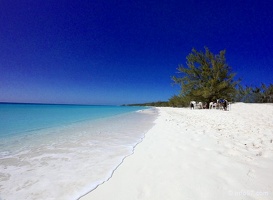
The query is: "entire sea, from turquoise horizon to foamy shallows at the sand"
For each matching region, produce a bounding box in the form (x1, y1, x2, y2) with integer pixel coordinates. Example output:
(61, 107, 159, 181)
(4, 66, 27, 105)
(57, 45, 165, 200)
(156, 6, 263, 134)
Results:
(0, 103, 157, 200)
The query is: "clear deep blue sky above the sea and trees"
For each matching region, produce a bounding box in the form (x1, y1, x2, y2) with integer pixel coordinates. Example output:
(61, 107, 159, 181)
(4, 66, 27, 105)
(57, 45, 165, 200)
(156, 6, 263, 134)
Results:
(0, 0, 273, 104)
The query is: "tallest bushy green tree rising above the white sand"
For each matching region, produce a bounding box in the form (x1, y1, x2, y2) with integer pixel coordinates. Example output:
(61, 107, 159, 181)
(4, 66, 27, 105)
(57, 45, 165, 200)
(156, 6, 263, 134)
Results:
(172, 47, 239, 107)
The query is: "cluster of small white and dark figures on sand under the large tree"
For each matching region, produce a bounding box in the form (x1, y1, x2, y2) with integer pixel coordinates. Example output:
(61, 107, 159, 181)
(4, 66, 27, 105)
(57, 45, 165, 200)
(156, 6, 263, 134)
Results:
(190, 99, 229, 110)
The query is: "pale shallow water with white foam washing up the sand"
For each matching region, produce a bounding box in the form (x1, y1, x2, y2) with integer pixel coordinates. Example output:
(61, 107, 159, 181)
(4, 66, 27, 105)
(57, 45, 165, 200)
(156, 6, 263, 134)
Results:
(0, 109, 157, 199)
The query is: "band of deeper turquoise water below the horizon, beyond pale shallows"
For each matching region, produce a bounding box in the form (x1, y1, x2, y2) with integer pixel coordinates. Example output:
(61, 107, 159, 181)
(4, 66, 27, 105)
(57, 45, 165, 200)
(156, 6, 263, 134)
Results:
(0, 104, 145, 138)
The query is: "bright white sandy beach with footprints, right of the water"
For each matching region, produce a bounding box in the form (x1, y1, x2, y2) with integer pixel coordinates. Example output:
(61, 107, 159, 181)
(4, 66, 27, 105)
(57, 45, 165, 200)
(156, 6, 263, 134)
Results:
(81, 103, 273, 200)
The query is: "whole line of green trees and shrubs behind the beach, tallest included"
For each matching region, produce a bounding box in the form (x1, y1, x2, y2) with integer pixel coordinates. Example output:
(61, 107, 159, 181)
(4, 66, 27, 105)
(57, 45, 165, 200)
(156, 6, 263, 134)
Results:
(127, 47, 273, 108)
